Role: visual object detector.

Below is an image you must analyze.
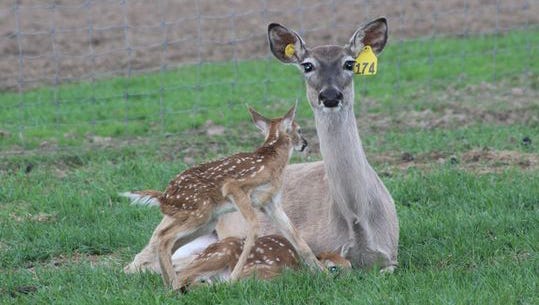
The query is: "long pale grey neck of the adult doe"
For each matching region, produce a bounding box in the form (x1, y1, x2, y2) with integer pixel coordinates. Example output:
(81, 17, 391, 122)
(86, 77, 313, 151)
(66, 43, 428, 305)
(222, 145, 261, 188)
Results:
(315, 96, 369, 218)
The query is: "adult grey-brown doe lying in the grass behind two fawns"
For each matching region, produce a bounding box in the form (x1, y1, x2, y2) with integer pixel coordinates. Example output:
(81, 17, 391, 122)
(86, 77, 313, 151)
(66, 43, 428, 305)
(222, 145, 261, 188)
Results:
(125, 18, 399, 272)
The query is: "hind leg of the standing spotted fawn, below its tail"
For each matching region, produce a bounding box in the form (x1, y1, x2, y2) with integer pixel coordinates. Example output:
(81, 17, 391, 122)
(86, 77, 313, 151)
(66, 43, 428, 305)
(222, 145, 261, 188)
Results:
(158, 215, 215, 290)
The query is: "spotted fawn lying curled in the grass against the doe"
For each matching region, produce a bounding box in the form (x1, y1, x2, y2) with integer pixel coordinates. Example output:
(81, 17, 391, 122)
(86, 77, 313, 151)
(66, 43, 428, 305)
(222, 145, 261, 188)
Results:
(179, 235, 352, 291)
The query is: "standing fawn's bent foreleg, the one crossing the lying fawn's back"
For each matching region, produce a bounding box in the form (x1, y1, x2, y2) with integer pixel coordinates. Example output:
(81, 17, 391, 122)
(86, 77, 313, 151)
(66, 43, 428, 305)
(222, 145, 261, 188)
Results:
(227, 185, 260, 281)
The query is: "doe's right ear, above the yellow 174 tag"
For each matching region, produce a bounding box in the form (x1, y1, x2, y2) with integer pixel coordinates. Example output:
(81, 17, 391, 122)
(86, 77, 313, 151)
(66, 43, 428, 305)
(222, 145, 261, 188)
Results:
(346, 17, 387, 57)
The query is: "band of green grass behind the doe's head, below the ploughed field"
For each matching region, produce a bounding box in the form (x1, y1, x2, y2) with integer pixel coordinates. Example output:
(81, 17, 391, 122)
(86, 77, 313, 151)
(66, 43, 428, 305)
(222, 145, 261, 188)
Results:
(0, 27, 539, 149)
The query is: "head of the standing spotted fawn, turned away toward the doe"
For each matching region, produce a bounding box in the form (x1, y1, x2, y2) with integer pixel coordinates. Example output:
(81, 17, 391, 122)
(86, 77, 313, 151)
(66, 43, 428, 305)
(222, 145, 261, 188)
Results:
(249, 105, 307, 151)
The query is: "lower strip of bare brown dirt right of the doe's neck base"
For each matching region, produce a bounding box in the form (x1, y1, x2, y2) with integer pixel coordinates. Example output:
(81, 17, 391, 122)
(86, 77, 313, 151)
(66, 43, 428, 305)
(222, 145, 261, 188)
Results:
(368, 149, 539, 175)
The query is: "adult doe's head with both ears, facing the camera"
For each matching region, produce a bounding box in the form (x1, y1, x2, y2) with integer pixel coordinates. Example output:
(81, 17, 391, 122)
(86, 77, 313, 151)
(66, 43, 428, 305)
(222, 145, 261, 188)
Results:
(268, 17, 387, 112)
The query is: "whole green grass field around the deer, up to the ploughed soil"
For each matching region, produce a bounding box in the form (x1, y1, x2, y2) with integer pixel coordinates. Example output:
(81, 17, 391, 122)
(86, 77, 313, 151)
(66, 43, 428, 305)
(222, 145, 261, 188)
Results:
(0, 30, 539, 304)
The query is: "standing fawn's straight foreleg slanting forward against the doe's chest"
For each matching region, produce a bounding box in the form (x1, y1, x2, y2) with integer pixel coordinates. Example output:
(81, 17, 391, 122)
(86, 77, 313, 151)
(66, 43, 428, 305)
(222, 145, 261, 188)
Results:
(264, 198, 325, 270)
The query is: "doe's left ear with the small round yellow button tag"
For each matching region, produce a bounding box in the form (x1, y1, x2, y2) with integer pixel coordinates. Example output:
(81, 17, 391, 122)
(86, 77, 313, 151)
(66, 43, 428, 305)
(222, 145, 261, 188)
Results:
(268, 23, 307, 64)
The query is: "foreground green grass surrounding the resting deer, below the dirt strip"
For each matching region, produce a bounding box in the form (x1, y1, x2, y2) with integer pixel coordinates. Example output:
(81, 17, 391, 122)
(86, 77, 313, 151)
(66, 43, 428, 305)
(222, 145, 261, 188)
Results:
(0, 150, 539, 304)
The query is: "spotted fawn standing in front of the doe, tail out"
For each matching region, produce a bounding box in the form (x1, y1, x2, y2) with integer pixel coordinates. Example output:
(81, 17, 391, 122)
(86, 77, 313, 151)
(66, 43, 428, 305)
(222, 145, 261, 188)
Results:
(121, 106, 321, 290)
